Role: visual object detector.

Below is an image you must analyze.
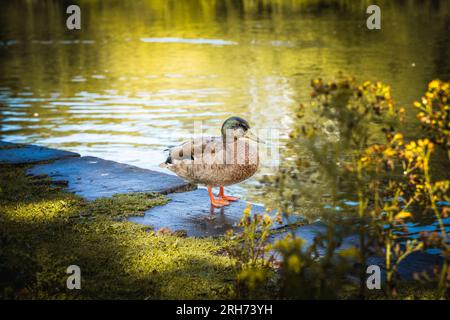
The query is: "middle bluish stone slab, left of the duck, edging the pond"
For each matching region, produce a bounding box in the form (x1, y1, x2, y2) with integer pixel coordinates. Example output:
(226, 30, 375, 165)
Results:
(27, 157, 195, 200)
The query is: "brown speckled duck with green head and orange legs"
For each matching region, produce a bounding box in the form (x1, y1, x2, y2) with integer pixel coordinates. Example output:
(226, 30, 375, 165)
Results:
(160, 117, 259, 208)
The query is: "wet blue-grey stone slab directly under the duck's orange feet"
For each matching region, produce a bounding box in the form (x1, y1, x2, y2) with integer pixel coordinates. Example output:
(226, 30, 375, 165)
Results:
(130, 189, 299, 237)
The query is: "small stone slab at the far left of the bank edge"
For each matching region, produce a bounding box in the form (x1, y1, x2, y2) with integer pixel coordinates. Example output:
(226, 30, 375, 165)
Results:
(0, 141, 80, 165)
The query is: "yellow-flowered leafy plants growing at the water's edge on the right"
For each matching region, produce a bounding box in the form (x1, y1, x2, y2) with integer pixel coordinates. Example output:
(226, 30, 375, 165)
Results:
(266, 74, 449, 298)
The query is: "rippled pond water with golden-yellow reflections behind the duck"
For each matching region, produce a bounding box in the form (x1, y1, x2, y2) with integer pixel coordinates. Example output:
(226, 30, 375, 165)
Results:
(0, 0, 450, 199)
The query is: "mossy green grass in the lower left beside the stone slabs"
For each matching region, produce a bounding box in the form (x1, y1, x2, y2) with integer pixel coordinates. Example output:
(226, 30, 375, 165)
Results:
(0, 165, 234, 299)
